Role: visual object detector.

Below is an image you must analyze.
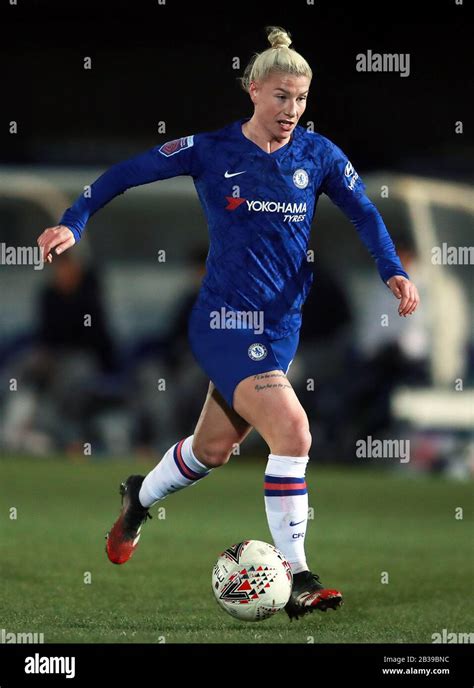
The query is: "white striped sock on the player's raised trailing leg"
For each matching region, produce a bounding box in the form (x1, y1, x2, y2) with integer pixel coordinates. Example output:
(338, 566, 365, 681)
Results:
(138, 435, 212, 508)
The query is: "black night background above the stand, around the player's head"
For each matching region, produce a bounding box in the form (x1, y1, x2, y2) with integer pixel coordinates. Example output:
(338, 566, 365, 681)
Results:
(0, 0, 474, 179)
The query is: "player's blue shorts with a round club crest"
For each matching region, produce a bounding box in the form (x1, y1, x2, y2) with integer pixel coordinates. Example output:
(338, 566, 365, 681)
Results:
(188, 306, 300, 408)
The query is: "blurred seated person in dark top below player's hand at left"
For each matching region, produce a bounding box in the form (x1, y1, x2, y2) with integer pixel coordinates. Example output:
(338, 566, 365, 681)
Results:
(3, 253, 118, 454)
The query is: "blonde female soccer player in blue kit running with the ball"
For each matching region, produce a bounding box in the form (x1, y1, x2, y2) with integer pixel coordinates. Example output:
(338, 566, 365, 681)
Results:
(38, 27, 419, 619)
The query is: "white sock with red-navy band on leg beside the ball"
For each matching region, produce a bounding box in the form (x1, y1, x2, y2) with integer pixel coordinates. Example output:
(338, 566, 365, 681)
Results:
(265, 454, 309, 573)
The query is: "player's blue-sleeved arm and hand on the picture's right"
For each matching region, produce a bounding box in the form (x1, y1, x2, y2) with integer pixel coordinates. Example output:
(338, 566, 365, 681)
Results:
(321, 140, 420, 317)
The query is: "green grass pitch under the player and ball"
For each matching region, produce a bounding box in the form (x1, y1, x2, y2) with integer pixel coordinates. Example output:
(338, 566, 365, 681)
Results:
(0, 456, 474, 643)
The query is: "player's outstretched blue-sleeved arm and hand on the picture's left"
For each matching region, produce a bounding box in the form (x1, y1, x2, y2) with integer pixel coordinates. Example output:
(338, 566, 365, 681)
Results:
(37, 136, 199, 263)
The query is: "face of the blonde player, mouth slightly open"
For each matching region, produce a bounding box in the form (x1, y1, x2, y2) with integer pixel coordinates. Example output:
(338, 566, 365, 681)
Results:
(250, 72, 311, 141)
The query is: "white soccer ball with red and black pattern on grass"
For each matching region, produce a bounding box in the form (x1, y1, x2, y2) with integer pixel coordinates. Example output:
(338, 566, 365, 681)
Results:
(212, 540, 293, 621)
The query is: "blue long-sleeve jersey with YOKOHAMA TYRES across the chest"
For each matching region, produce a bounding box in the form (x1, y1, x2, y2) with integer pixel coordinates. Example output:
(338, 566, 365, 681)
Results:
(59, 118, 408, 339)
